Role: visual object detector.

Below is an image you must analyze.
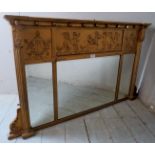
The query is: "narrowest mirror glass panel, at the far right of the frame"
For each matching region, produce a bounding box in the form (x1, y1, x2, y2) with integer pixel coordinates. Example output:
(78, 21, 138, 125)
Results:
(118, 54, 134, 99)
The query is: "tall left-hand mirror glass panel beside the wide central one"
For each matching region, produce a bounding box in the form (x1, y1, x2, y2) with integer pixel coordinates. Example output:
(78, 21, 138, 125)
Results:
(26, 63, 54, 127)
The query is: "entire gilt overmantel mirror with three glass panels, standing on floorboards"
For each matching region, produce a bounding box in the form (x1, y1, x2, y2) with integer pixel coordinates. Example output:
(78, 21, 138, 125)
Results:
(5, 16, 149, 139)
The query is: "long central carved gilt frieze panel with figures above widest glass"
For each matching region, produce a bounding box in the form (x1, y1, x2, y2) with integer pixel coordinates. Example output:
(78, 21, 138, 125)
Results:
(54, 29, 122, 55)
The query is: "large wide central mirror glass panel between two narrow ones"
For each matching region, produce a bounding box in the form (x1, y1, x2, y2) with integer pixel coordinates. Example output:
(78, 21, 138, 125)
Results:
(57, 56, 119, 118)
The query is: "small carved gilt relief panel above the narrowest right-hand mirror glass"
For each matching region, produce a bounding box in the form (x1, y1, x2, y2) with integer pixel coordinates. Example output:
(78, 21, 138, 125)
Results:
(123, 31, 137, 51)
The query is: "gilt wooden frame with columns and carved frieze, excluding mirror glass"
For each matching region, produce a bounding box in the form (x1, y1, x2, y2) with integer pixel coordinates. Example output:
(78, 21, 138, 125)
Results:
(5, 15, 150, 139)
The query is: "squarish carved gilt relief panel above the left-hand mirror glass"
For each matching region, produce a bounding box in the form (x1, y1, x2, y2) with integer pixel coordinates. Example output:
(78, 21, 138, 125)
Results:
(15, 29, 51, 63)
